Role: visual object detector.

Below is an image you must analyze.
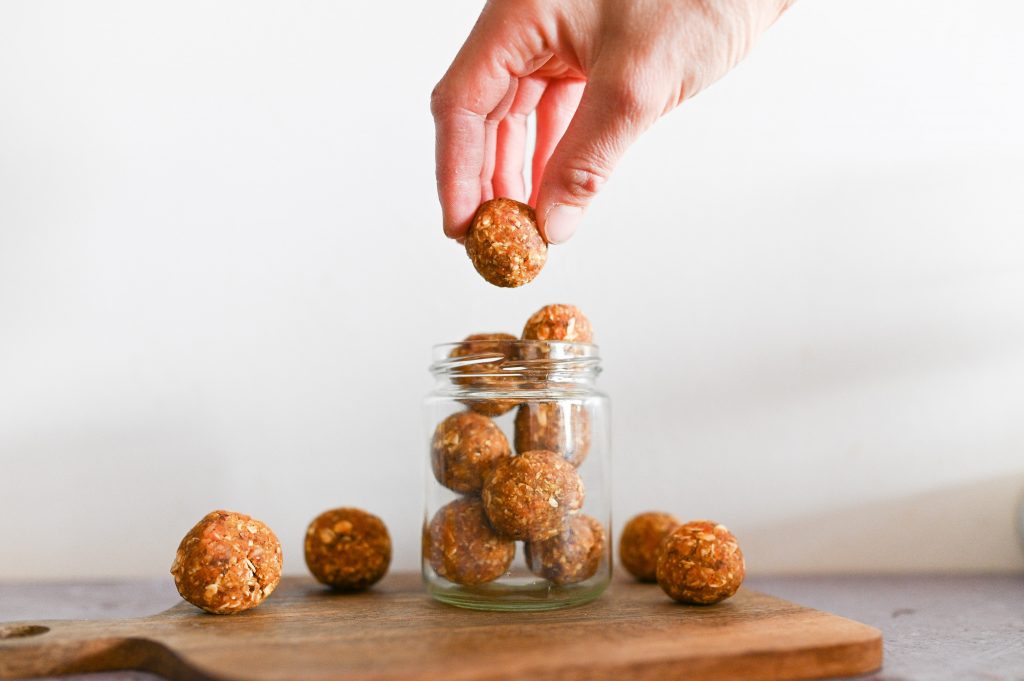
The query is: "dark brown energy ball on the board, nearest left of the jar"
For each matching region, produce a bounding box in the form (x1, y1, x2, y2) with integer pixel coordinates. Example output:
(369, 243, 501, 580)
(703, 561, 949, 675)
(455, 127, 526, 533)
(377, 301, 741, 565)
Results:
(305, 508, 391, 591)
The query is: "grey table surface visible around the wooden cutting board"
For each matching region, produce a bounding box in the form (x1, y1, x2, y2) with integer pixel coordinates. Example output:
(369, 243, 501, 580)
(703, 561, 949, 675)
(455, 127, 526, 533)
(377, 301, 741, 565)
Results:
(0, 574, 1024, 681)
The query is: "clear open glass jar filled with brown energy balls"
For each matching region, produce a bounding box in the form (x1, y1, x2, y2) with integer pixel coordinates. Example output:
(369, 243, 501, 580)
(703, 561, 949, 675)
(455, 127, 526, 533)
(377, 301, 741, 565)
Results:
(423, 339, 611, 610)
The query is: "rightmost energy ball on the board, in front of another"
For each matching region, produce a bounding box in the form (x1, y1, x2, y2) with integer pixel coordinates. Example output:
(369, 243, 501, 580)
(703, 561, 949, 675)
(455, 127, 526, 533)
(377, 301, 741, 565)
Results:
(657, 520, 745, 605)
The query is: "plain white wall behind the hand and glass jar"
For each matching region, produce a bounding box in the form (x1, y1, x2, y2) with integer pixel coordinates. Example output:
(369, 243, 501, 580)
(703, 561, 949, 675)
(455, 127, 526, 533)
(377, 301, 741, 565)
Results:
(0, 0, 1024, 579)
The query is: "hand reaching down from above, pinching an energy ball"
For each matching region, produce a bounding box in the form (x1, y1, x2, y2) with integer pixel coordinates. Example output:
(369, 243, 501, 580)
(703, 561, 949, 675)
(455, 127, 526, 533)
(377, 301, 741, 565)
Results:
(430, 0, 793, 244)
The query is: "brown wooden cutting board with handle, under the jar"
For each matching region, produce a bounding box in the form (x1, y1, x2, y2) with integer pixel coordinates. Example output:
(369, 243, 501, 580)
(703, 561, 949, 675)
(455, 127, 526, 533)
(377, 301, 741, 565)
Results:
(0, 573, 882, 681)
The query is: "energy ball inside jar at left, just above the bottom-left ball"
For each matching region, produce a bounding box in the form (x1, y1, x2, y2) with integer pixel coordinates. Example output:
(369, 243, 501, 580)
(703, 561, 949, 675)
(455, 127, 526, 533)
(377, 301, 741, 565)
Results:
(430, 412, 512, 495)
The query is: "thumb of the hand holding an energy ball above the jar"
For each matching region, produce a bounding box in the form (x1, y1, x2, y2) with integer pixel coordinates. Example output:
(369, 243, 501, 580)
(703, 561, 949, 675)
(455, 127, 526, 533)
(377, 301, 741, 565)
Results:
(537, 77, 656, 244)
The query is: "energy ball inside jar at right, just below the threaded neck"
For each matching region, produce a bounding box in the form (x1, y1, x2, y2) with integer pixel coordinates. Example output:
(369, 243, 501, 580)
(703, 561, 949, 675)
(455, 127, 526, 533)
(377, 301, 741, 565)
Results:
(515, 402, 590, 468)
